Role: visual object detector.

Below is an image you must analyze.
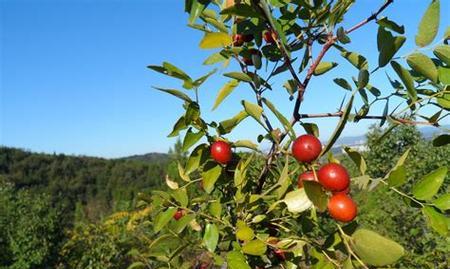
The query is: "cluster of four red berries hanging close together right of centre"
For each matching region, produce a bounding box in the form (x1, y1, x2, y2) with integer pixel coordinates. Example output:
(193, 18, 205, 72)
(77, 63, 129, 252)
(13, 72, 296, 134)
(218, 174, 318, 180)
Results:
(292, 135, 357, 222)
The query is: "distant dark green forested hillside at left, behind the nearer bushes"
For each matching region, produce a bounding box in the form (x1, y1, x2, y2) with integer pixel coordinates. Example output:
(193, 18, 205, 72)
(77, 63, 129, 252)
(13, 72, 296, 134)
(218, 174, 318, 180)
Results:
(0, 147, 170, 221)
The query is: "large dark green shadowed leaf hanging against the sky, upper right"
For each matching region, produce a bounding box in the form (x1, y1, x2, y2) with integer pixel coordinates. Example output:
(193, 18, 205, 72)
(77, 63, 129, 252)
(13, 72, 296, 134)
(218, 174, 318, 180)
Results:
(377, 27, 406, 67)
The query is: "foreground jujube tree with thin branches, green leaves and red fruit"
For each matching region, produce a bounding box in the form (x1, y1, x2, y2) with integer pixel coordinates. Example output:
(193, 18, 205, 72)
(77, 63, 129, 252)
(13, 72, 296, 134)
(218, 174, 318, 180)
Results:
(124, 0, 450, 269)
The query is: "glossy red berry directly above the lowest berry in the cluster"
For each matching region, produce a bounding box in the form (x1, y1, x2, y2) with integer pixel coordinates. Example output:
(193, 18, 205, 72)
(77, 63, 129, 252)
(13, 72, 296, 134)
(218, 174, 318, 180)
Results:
(317, 163, 350, 192)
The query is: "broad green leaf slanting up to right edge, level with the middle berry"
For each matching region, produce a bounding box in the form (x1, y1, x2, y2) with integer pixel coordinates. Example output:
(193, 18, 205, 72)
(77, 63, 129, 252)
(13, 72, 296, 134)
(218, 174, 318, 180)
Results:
(412, 167, 447, 200)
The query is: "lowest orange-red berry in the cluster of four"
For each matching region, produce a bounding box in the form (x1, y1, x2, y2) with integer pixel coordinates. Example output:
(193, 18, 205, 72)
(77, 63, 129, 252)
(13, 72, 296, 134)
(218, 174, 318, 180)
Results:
(328, 193, 358, 222)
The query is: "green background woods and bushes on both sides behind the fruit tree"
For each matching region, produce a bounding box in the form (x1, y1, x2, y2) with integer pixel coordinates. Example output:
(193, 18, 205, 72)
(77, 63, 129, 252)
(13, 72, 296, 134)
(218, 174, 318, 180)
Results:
(0, 126, 450, 269)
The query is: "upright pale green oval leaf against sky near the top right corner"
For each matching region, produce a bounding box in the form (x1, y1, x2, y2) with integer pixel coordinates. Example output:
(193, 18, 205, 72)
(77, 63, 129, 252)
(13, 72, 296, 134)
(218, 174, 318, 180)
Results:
(416, 0, 441, 47)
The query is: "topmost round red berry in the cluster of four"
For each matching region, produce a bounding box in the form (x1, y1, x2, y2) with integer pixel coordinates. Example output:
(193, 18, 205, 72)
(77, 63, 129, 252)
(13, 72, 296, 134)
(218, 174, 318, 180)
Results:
(292, 134, 322, 163)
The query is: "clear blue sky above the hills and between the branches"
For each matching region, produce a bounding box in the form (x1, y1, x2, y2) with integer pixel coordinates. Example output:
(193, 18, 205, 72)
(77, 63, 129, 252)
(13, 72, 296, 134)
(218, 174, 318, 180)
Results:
(0, 0, 450, 157)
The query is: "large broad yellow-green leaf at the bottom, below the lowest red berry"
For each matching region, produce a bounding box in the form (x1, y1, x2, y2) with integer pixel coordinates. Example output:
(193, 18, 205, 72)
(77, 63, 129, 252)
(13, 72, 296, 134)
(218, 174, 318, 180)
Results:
(351, 229, 405, 266)
